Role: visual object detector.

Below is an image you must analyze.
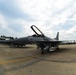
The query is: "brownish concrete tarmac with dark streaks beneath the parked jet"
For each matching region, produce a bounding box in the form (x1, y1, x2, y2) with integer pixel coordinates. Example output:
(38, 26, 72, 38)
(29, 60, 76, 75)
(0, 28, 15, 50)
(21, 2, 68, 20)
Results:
(0, 44, 76, 75)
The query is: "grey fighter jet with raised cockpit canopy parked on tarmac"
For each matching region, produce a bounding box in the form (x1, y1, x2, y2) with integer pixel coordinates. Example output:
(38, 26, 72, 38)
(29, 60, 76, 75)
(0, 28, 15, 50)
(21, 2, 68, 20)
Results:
(0, 25, 62, 54)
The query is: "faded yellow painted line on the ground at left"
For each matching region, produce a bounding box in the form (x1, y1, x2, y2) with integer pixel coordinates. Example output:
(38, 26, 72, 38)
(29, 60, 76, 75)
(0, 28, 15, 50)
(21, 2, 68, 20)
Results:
(0, 54, 43, 65)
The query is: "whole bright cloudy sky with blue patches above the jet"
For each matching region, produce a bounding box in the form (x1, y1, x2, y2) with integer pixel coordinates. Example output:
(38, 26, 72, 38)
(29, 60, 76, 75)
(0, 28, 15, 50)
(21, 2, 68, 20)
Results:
(0, 0, 76, 40)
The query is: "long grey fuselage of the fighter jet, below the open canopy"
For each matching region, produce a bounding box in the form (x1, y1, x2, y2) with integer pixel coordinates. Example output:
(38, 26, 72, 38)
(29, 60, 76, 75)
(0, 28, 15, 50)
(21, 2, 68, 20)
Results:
(7, 36, 53, 44)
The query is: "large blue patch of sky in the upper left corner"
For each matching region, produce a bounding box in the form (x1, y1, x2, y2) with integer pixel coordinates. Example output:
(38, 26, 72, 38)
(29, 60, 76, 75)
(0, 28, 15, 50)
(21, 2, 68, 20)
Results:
(0, 0, 32, 21)
